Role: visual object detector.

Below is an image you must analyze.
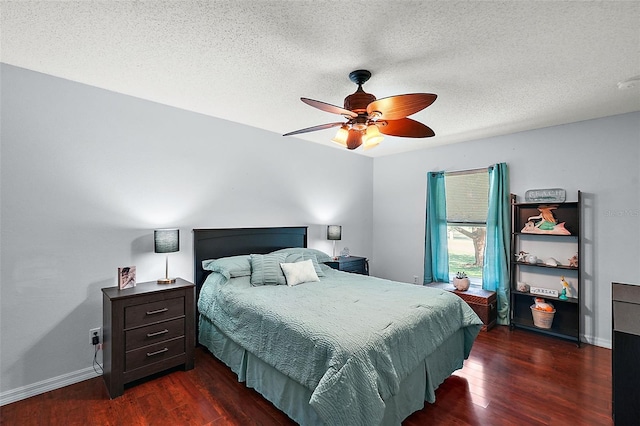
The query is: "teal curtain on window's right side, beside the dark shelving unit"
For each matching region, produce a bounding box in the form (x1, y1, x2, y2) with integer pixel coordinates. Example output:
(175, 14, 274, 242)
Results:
(482, 163, 511, 325)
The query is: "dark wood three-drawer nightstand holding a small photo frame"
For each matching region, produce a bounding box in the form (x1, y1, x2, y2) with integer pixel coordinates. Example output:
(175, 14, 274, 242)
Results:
(102, 278, 196, 398)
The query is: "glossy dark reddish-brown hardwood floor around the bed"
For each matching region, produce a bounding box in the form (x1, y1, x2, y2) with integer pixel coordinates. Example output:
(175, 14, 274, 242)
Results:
(0, 327, 613, 426)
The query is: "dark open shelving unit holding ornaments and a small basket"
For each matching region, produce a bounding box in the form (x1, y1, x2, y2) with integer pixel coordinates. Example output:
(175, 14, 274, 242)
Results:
(509, 191, 582, 346)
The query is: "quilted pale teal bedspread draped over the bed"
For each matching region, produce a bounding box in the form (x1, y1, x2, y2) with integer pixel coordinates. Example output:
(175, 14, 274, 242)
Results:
(198, 265, 482, 425)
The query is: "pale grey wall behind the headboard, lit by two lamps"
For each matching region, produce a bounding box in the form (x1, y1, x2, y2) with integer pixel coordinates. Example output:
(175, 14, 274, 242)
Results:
(0, 65, 373, 402)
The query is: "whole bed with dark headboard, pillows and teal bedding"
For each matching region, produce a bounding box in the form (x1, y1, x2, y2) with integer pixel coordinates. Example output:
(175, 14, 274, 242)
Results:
(194, 227, 482, 425)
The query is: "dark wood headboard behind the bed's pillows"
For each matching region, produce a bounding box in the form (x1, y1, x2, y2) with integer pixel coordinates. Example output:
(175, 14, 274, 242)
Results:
(193, 226, 307, 300)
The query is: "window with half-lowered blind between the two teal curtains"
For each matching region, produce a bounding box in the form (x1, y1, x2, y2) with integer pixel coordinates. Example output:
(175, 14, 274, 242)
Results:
(444, 169, 489, 286)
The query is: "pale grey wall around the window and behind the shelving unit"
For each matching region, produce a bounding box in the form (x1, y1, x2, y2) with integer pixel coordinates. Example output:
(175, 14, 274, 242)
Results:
(371, 113, 640, 347)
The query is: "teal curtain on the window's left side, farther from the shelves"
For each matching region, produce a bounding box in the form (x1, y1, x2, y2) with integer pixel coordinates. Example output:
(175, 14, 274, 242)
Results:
(423, 172, 449, 284)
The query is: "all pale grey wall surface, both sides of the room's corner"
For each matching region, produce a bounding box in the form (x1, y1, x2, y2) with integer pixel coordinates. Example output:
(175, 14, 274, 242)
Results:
(0, 61, 640, 403)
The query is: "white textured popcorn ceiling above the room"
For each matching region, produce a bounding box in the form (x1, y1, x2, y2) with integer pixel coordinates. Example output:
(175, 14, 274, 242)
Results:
(0, 0, 640, 157)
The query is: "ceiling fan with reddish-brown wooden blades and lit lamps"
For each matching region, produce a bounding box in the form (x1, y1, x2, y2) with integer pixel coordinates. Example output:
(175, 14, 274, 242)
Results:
(283, 70, 438, 149)
